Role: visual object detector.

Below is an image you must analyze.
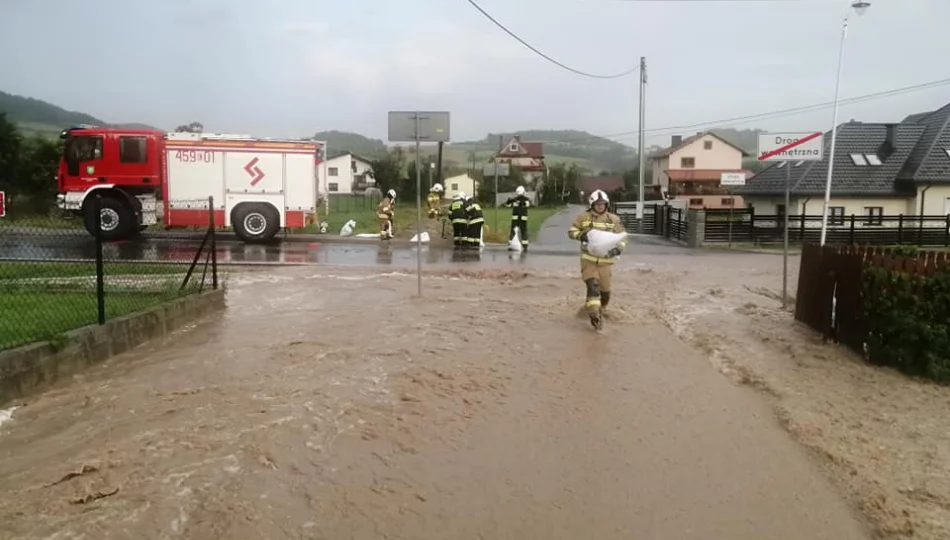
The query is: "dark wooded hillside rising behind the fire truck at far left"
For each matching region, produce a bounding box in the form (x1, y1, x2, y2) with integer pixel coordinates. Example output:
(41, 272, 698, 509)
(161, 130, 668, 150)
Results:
(0, 91, 156, 137)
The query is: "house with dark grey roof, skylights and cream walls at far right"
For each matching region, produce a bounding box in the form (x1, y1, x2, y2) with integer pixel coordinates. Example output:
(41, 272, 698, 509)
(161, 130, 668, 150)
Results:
(737, 104, 950, 226)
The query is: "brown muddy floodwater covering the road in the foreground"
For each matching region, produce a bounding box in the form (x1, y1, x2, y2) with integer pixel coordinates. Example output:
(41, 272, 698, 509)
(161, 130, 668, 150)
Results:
(0, 251, 939, 540)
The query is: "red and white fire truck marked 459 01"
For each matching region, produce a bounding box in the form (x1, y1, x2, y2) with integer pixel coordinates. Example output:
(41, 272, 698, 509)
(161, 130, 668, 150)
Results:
(57, 126, 326, 243)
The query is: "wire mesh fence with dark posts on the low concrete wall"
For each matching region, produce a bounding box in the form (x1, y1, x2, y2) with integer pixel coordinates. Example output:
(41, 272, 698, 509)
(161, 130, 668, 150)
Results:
(0, 199, 224, 350)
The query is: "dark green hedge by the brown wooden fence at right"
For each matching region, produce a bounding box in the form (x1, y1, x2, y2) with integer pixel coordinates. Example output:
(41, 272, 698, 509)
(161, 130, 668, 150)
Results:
(862, 265, 950, 384)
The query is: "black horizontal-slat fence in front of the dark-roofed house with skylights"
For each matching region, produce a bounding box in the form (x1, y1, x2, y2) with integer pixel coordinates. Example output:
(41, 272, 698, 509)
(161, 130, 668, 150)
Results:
(704, 208, 950, 247)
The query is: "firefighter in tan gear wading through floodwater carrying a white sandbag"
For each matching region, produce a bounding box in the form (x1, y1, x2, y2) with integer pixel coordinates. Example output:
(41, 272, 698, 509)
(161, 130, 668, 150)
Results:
(567, 189, 627, 330)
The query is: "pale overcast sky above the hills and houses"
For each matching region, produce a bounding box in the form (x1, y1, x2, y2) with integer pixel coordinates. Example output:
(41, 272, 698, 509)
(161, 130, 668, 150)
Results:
(0, 0, 950, 145)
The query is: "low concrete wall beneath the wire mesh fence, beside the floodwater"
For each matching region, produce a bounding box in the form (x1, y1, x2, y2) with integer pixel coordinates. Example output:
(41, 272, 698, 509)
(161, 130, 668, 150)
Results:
(0, 289, 225, 405)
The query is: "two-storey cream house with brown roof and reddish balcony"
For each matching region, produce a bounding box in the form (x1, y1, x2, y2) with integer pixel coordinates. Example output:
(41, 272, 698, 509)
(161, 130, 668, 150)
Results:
(645, 132, 752, 208)
